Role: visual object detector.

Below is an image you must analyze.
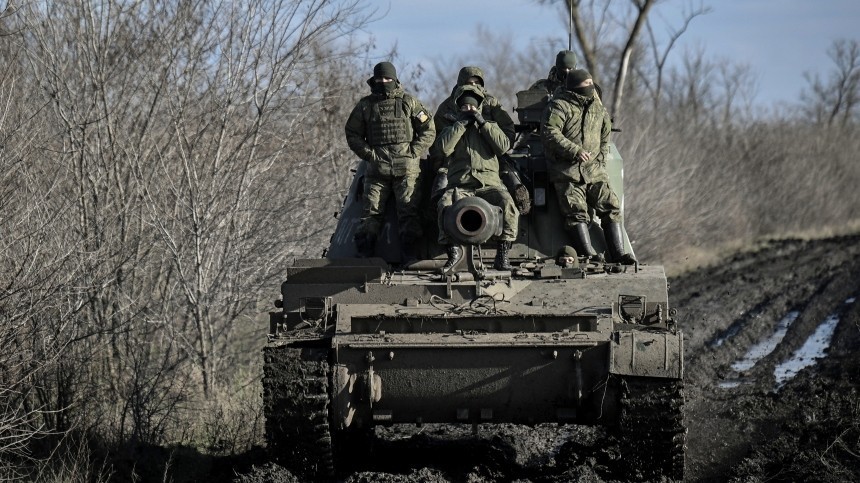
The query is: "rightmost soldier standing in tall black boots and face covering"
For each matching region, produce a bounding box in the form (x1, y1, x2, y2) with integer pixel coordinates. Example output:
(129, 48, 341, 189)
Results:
(541, 70, 636, 265)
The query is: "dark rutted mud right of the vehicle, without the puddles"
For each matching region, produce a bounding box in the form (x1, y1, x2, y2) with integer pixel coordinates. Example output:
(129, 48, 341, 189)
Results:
(670, 236, 860, 481)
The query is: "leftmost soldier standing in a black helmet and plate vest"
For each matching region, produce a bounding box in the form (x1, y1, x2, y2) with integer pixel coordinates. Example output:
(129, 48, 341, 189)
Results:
(345, 62, 436, 264)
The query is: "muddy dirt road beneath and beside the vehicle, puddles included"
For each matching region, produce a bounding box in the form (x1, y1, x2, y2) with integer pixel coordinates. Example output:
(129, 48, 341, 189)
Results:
(237, 236, 860, 482)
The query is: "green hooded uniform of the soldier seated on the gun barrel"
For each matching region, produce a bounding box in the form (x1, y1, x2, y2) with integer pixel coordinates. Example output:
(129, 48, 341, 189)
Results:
(434, 86, 520, 245)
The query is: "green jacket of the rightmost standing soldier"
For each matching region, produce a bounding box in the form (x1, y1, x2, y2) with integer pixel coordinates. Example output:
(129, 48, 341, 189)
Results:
(541, 88, 612, 183)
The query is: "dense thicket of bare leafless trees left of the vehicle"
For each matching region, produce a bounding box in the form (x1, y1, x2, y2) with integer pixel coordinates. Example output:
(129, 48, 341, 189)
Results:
(0, 0, 380, 472)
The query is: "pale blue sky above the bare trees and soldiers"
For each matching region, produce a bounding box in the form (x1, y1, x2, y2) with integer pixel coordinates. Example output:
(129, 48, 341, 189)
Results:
(370, 0, 860, 108)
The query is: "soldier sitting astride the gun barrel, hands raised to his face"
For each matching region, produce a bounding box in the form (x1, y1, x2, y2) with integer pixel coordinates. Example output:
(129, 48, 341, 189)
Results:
(435, 85, 520, 273)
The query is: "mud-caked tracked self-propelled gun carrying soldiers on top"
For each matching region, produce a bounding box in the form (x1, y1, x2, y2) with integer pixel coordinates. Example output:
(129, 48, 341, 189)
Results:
(263, 86, 686, 479)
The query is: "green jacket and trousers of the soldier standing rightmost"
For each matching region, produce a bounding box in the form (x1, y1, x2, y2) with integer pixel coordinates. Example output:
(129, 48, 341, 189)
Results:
(541, 87, 621, 228)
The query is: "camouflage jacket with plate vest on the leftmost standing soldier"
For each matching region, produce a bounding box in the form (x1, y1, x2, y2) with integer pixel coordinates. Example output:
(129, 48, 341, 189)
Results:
(345, 83, 436, 176)
